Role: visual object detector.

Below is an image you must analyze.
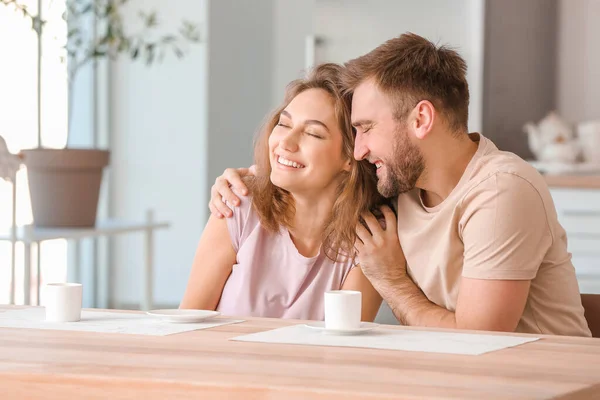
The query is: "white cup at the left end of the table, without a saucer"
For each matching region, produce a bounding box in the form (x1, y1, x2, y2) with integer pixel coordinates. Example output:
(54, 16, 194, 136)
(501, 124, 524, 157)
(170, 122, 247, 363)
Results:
(43, 283, 83, 322)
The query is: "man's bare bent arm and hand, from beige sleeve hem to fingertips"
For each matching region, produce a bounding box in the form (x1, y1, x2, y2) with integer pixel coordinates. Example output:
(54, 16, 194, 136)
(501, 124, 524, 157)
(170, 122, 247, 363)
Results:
(355, 206, 529, 332)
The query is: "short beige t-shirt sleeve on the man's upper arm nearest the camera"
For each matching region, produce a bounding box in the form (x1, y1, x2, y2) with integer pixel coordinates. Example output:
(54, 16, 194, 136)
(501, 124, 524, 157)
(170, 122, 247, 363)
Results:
(459, 173, 552, 280)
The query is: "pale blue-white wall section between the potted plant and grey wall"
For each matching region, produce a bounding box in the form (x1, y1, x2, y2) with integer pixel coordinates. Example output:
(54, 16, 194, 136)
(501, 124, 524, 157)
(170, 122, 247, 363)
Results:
(110, 0, 208, 307)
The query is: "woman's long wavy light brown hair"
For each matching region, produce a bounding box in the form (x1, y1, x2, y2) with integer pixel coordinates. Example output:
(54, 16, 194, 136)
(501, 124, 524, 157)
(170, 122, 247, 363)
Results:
(246, 63, 383, 261)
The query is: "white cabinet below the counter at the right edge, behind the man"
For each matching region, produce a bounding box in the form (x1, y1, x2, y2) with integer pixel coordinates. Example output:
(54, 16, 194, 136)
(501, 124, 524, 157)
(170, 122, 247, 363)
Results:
(550, 189, 600, 293)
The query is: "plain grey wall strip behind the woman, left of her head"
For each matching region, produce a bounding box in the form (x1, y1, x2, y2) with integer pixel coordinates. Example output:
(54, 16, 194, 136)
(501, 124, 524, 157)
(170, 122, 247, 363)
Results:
(202, 0, 274, 183)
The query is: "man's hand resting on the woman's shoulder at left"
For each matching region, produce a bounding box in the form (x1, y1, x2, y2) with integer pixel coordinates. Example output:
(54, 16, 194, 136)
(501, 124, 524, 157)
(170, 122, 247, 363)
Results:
(208, 165, 256, 218)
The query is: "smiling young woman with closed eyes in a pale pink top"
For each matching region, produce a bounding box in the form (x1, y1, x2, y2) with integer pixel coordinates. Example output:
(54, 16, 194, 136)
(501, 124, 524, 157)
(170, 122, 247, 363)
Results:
(180, 64, 382, 321)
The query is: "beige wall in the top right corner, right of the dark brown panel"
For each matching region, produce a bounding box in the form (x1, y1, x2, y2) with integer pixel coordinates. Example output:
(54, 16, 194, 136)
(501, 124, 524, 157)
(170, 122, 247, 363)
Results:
(557, 0, 600, 123)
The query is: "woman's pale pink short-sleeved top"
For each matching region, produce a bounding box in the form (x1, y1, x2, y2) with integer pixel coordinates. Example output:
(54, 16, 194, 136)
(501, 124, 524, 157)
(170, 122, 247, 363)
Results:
(217, 195, 354, 320)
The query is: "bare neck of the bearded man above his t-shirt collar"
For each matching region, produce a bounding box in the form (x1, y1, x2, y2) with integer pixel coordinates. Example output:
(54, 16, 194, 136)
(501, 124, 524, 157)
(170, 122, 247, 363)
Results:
(417, 132, 478, 207)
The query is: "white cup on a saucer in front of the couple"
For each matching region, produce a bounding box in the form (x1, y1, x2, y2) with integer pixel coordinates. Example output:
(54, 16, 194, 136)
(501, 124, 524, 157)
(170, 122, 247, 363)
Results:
(325, 290, 362, 329)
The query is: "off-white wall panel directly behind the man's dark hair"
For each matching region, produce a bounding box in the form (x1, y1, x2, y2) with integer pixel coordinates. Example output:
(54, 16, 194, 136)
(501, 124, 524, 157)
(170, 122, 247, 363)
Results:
(315, 0, 484, 131)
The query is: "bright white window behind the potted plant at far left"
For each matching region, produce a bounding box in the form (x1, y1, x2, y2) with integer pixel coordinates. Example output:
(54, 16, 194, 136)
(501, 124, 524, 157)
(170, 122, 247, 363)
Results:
(0, 0, 68, 304)
